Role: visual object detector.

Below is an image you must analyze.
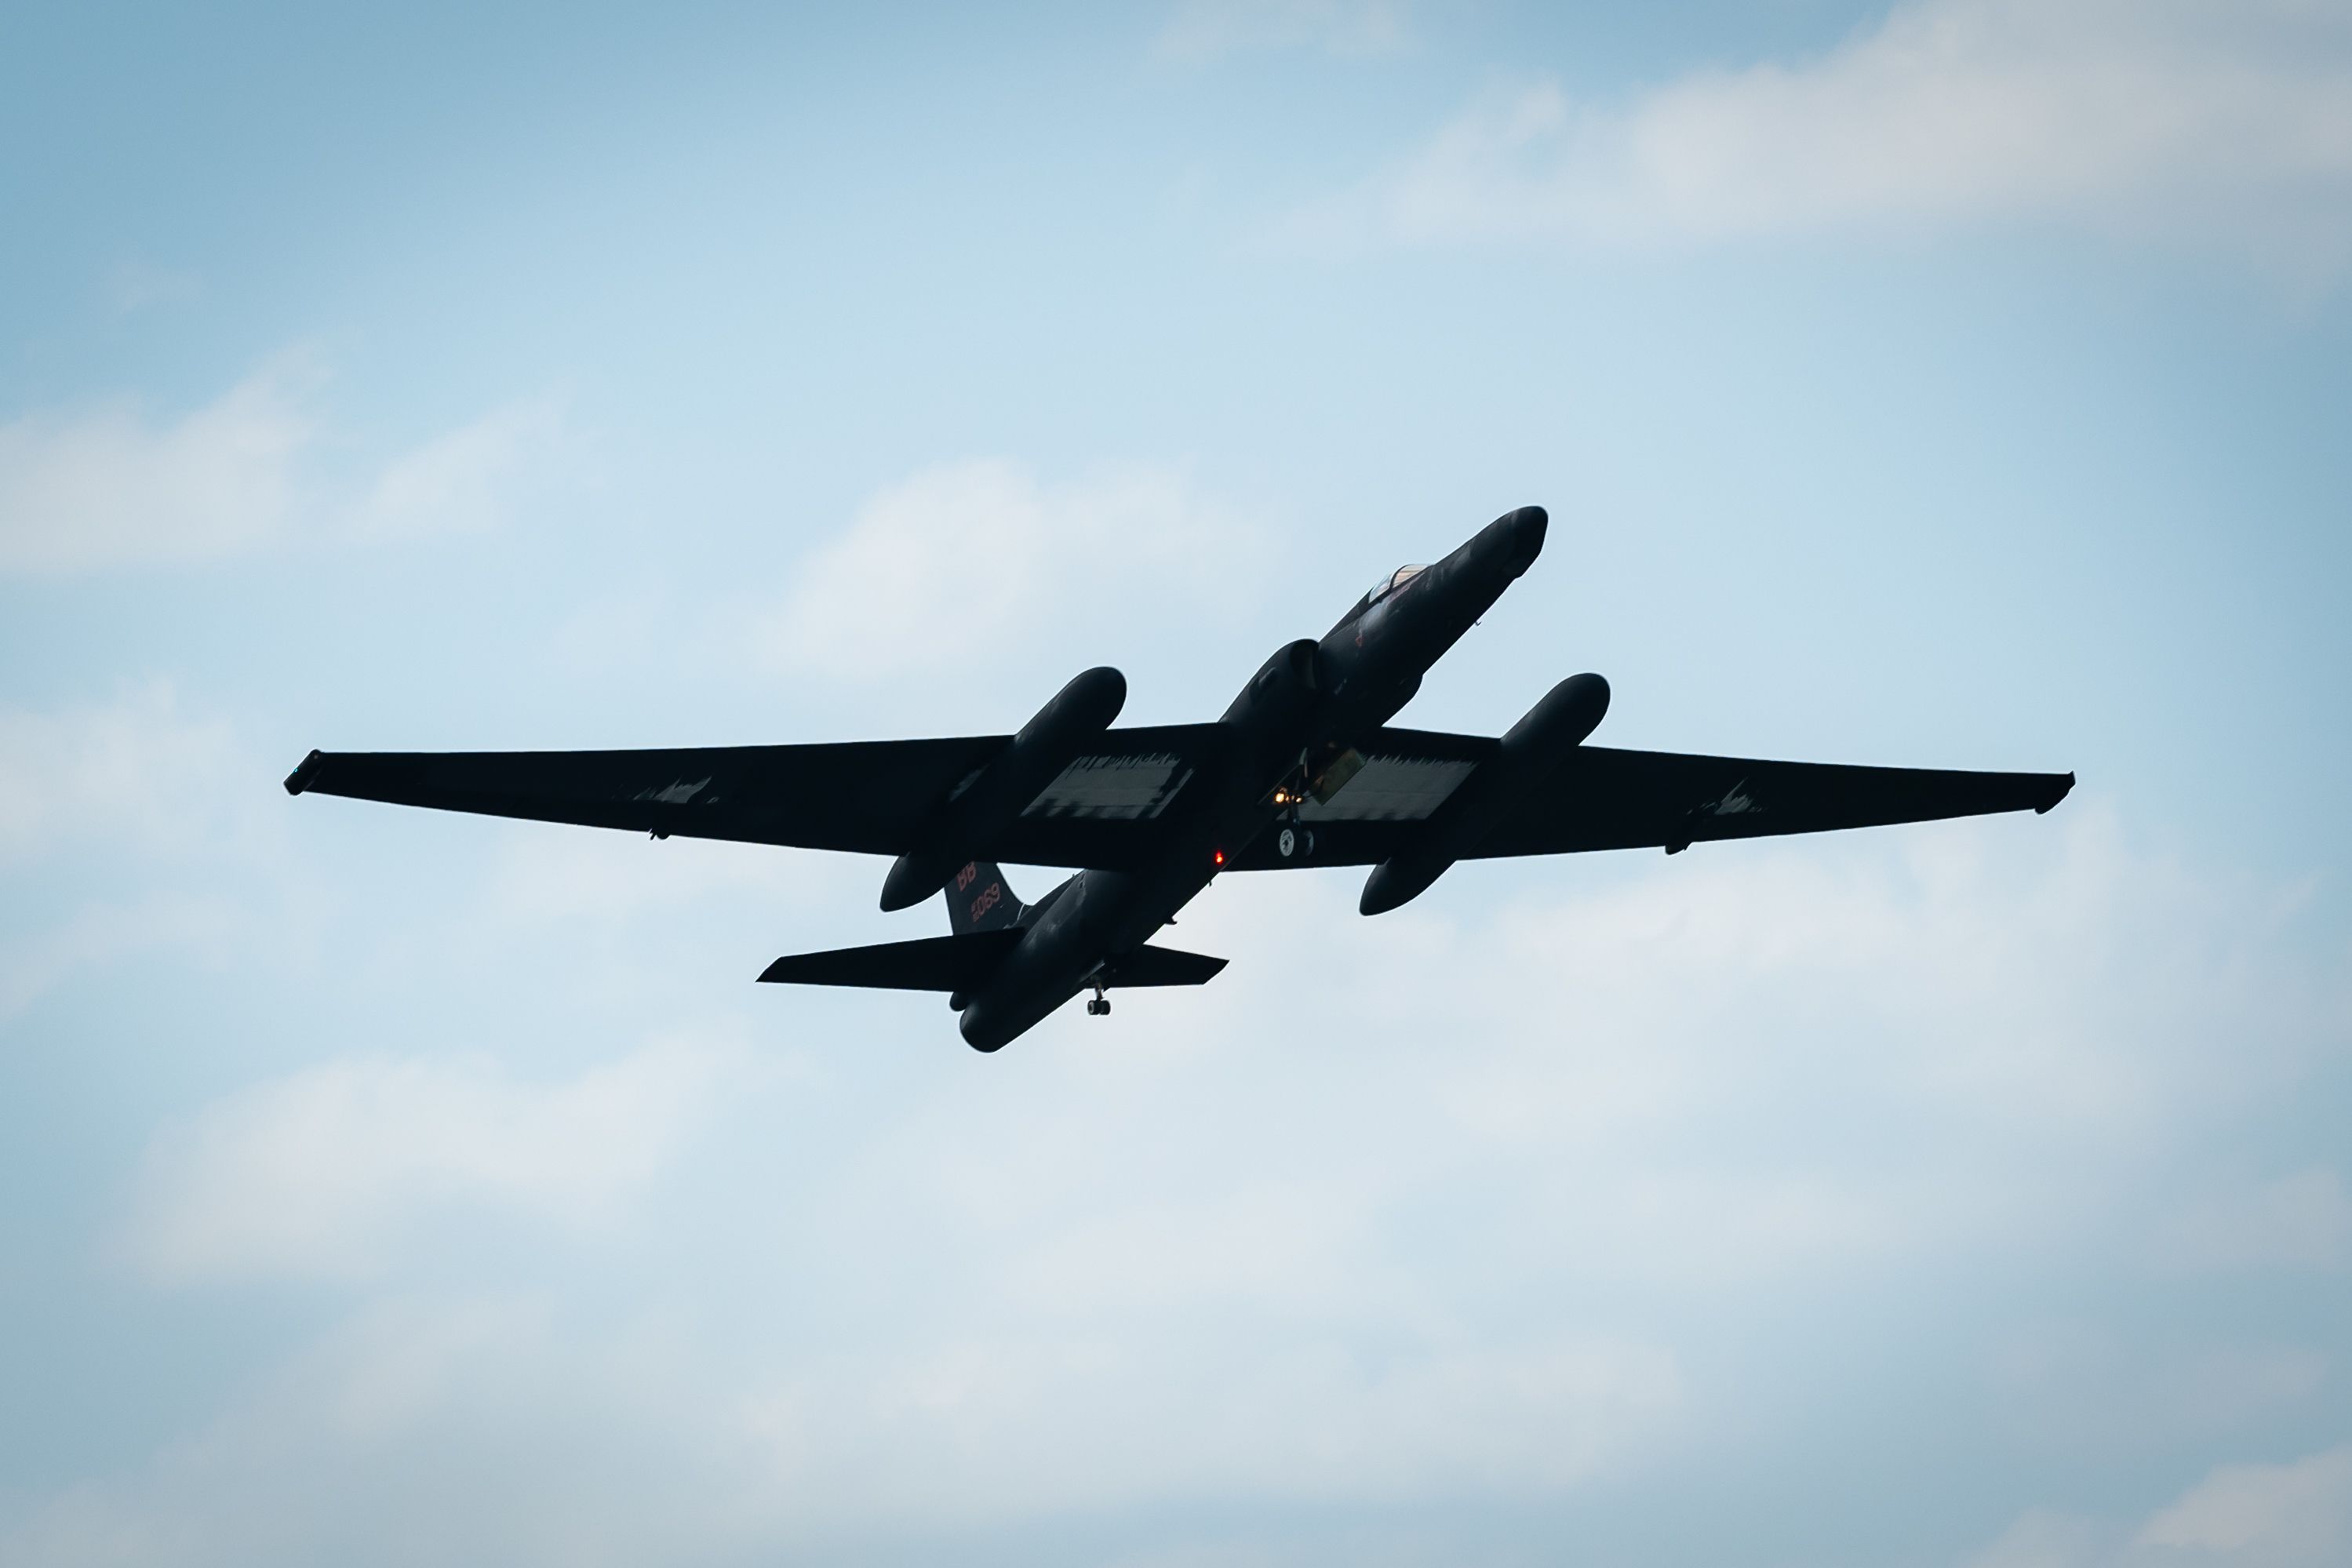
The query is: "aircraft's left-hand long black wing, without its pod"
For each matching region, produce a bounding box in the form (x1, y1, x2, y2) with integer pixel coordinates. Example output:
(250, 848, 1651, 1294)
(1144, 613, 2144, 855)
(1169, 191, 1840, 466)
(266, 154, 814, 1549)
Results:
(287, 724, 1221, 870)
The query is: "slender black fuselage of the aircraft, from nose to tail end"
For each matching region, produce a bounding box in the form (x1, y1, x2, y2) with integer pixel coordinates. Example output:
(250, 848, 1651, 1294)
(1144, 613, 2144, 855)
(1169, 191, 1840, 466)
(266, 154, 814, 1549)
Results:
(959, 505, 1546, 1051)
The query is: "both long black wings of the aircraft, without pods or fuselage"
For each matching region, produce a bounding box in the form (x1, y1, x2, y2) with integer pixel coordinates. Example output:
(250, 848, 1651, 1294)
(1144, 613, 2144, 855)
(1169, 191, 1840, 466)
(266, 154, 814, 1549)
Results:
(287, 724, 2074, 870)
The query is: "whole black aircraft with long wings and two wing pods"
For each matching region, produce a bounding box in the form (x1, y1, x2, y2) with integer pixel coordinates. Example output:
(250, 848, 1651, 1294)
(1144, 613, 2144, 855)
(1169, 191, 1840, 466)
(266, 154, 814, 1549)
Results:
(287, 505, 2074, 1051)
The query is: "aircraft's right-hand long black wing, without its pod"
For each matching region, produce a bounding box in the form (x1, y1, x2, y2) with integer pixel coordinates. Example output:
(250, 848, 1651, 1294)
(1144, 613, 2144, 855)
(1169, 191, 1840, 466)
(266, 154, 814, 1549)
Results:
(1232, 729, 2074, 870)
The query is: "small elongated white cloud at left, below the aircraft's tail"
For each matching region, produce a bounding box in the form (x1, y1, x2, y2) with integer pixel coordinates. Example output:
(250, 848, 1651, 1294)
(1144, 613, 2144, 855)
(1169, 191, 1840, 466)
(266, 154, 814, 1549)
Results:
(122, 1044, 729, 1281)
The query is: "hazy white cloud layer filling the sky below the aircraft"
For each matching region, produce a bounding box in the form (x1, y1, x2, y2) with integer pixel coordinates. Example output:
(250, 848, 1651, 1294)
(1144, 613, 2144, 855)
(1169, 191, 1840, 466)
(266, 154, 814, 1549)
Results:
(9, 802, 2345, 1568)
